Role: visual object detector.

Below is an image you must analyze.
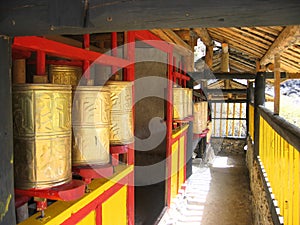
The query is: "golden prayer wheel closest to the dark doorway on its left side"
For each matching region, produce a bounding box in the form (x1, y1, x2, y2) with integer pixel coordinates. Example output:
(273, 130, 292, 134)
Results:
(107, 81, 133, 145)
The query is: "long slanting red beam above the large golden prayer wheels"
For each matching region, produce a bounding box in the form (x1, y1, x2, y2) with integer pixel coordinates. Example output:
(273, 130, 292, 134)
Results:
(12, 36, 131, 67)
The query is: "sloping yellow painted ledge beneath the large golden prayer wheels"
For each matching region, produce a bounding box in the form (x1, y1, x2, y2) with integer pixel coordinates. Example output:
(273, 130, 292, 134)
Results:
(19, 165, 133, 225)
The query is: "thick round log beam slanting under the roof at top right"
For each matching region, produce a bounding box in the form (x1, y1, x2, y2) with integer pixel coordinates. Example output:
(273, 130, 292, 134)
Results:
(260, 26, 300, 65)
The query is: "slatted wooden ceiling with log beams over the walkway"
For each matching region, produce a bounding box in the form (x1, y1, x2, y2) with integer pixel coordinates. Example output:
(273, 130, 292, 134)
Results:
(151, 26, 300, 73)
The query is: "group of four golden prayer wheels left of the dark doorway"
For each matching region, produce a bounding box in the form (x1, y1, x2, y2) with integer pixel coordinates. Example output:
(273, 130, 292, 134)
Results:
(13, 66, 133, 189)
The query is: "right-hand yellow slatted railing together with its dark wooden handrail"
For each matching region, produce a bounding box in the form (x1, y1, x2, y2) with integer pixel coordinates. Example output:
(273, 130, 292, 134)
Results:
(256, 106, 300, 225)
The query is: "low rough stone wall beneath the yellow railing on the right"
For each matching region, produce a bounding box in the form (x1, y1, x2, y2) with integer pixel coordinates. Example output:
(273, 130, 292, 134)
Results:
(246, 140, 273, 225)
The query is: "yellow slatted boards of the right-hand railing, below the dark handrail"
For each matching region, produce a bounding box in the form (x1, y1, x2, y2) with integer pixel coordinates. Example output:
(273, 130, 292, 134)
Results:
(258, 110, 300, 225)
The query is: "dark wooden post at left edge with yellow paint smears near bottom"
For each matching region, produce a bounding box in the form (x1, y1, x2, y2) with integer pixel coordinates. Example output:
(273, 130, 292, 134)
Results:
(0, 36, 16, 225)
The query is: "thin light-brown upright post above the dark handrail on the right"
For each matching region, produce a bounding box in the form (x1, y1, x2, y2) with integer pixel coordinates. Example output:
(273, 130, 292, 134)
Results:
(274, 54, 280, 115)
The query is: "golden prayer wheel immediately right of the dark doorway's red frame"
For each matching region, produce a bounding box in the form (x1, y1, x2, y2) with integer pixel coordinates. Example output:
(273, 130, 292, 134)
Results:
(173, 88, 185, 119)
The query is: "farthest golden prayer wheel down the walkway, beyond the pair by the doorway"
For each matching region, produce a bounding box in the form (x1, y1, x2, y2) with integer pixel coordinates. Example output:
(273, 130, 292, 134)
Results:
(193, 102, 207, 134)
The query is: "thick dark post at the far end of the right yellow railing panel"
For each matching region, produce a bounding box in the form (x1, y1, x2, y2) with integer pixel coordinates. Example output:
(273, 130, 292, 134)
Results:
(254, 73, 266, 156)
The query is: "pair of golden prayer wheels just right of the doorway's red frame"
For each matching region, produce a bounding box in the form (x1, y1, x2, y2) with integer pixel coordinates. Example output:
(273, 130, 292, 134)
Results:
(173, 88, 193, 120)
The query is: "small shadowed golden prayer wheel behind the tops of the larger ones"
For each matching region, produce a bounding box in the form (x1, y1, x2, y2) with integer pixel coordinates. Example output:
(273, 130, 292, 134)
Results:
(49, 65, 82, 86)
